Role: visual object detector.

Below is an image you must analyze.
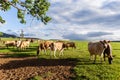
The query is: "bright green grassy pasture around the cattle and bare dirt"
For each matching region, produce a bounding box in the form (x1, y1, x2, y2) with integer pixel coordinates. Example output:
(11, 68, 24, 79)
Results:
(0, 38, 120, 80)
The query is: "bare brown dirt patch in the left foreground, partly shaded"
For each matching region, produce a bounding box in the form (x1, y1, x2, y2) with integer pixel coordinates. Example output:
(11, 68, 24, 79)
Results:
(0, 54, 76, 80)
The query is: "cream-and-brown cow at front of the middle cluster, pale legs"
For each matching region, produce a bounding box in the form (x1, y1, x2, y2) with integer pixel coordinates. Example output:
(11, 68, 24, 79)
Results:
(50, 42, 65, 57)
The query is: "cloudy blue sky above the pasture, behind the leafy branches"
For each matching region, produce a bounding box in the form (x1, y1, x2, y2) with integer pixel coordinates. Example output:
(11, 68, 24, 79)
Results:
(0, 0, 120, 40)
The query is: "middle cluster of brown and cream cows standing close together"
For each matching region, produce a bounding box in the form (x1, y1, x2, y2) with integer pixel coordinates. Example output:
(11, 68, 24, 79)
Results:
(37, 41, 76, 57)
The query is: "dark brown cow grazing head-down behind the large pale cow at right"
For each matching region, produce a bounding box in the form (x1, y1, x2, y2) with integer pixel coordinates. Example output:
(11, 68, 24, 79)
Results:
(103, 41, 113, 64)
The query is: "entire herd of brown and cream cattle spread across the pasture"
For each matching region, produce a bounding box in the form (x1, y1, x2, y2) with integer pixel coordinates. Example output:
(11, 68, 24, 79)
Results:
(0, 39, 113, 64)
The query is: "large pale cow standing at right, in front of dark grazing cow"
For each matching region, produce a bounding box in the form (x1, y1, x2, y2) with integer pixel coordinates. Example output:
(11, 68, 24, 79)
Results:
(88, 40, 109, 63)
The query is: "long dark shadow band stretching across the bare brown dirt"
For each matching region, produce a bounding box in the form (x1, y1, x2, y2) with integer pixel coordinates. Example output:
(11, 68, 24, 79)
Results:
(0, 57, 78, 70)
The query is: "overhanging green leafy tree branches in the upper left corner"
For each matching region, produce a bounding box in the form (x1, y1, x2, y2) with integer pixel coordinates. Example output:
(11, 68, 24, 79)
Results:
(0, 0, 51, 24)
